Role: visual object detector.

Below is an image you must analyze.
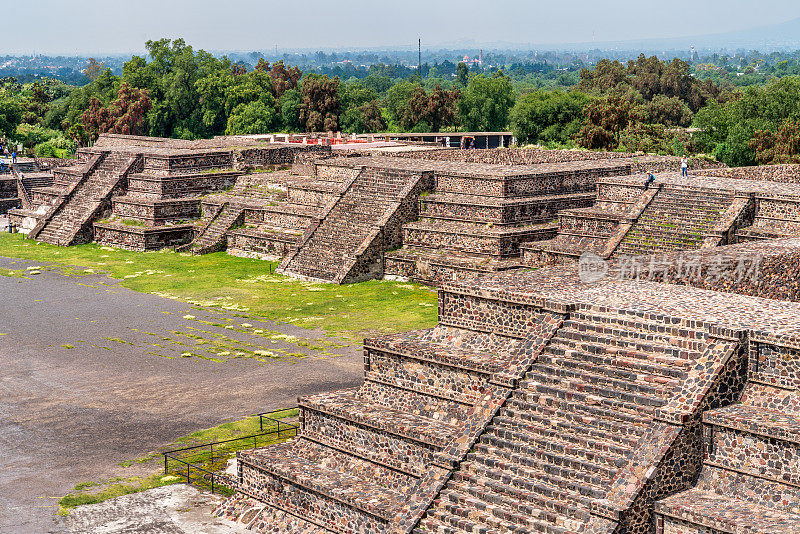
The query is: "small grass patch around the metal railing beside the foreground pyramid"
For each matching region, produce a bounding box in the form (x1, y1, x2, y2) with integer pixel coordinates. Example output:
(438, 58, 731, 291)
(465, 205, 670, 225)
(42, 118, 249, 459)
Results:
(58, 409, 298, 515)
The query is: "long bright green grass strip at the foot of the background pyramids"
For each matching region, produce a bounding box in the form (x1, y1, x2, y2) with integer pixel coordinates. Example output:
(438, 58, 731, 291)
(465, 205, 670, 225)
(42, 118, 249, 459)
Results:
(0, 233, 437, 341)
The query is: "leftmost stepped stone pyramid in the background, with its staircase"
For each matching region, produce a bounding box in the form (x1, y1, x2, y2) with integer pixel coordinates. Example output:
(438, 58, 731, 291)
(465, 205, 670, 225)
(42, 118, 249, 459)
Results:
(11, 134, 329, 250)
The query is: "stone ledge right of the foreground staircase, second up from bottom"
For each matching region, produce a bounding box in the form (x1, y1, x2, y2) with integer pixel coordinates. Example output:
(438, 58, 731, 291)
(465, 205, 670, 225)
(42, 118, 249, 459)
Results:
(703, 404, 800, 444)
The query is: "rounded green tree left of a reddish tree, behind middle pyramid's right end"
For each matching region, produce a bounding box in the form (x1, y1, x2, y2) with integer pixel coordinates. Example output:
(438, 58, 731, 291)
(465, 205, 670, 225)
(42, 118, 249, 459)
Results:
(511, 91, 589, 144)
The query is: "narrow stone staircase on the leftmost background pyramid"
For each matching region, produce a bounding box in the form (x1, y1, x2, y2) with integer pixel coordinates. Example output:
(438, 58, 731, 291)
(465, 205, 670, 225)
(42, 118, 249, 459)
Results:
(28, 152, 140, 246)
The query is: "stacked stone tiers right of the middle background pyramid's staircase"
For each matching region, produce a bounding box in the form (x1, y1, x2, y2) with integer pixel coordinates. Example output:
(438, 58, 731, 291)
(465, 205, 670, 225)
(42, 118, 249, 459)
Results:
(384, 158, 631, 285)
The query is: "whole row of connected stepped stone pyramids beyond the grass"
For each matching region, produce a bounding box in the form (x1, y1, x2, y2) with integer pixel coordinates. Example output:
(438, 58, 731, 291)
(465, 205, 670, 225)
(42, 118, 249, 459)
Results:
(12, 134, 800, 285)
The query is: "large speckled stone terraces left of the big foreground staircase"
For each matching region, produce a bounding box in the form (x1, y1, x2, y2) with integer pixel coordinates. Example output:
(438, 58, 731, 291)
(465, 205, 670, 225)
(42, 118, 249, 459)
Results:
(231, 314, 552, 534)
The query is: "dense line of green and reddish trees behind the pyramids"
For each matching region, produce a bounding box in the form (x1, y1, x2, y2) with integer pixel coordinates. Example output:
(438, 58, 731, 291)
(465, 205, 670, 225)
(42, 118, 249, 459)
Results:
(0, 39, 800, 165)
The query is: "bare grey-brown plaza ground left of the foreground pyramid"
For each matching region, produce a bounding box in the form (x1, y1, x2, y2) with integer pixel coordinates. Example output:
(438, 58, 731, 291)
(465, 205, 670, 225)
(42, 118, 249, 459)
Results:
(0, 258, 362, 533)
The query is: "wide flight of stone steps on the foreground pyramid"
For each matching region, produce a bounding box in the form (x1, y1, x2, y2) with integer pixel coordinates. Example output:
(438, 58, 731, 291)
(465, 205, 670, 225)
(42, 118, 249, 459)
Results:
(414, 311, 705, 534)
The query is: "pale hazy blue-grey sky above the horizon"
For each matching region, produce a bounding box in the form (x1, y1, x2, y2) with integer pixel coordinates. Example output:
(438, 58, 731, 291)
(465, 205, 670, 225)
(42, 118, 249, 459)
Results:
(0, 0, 800, 54)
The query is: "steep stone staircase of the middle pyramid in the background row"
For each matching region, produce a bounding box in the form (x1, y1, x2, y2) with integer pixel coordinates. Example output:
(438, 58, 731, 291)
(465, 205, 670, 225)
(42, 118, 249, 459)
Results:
(278, 167, 426, 283)
